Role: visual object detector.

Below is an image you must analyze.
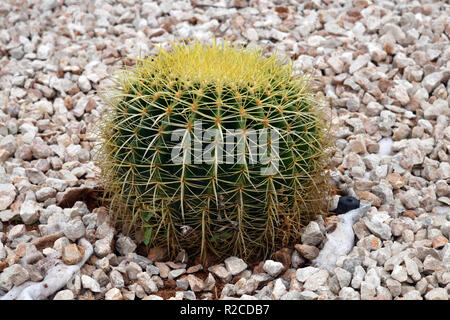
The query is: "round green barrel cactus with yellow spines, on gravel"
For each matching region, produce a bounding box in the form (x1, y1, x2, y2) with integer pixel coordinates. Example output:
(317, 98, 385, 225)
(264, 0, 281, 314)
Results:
(98, 42, 330, 258)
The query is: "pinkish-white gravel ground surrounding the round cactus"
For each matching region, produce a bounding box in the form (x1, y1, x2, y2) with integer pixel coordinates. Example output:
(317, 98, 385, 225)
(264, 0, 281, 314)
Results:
(0, 0, 450, 300)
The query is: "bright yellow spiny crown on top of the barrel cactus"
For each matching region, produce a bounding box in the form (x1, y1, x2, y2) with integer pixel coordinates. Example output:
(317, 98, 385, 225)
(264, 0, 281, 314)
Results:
(115, 42, 292, 90)
